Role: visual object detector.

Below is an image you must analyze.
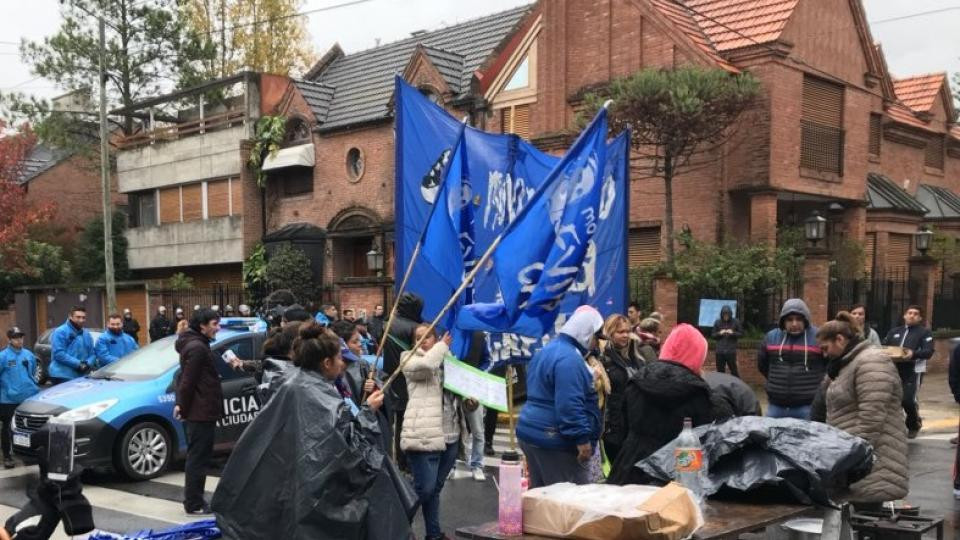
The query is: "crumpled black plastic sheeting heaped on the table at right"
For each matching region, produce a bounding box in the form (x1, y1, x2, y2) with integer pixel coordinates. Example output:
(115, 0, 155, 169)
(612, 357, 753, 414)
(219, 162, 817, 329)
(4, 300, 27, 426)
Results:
(636, 416, 874, 505)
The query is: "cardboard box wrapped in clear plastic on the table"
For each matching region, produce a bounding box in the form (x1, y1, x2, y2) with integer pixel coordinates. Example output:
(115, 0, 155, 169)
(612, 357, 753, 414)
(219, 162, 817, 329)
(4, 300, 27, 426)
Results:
(523, 483, 704, 540)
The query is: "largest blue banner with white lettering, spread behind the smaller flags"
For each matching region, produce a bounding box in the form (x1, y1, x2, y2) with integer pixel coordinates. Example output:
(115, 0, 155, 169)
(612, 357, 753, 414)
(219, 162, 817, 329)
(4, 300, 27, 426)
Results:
(394, 78, 629, 363)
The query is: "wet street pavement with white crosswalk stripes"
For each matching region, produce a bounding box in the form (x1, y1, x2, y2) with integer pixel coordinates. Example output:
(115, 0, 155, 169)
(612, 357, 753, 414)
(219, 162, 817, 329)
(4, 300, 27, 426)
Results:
(0, 408, 960, 539)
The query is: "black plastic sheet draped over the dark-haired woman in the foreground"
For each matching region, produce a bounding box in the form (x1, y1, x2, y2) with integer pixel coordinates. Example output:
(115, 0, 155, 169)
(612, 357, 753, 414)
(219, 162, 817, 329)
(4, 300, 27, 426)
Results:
(212, 367, 415, 540)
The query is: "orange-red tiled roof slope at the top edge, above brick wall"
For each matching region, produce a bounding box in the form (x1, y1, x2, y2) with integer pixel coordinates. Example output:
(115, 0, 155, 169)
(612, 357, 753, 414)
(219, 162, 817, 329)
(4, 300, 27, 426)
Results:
(684, 0, 799, 52)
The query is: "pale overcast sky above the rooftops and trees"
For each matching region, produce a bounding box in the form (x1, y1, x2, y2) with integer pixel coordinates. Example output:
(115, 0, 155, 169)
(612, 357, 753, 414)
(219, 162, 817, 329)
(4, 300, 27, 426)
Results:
(0, 0, 960, 103)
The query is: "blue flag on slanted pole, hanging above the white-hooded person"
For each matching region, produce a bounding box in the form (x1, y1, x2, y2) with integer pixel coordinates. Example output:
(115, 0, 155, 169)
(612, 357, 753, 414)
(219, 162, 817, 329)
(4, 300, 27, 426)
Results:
(459, 109, 607, 336)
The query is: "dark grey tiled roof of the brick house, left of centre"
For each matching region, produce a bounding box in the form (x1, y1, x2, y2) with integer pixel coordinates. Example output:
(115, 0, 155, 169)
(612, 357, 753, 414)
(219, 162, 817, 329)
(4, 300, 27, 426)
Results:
(310, 5, 532, 130)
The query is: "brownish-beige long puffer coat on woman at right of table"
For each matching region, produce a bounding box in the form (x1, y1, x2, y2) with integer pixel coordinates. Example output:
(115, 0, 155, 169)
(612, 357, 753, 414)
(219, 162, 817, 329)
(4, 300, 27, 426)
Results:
(827, 342, 909, 502)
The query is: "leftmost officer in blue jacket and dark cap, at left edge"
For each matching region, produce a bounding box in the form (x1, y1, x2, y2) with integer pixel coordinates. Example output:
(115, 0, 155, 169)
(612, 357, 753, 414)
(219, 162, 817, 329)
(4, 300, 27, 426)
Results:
(0, 326, 40, 469)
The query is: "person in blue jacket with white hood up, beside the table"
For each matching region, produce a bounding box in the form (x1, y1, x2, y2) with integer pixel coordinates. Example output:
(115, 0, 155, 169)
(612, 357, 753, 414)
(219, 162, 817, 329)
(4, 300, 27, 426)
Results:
(517, 306, 603, 488)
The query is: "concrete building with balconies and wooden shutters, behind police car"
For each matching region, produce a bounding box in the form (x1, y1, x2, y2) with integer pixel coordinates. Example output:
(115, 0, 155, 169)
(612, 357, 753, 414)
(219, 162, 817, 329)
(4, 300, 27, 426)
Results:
(113, 73, 278, 292)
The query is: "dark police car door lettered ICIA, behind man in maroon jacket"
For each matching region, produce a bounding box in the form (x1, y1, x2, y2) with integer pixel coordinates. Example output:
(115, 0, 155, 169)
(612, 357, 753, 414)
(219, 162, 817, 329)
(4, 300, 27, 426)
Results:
(213, 335, 260, 448)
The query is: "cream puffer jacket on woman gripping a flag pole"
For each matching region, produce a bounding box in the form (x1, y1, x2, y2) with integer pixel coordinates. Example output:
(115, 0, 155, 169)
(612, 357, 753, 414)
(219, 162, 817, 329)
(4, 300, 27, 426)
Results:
(400, 341, 460, 452)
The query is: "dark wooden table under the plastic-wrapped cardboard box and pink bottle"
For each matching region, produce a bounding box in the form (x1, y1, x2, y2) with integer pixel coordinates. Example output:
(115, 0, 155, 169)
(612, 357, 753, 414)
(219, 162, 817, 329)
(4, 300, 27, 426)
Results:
(457, 501, 816, 540)
